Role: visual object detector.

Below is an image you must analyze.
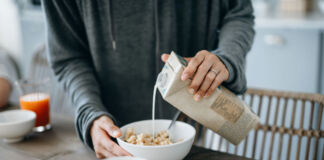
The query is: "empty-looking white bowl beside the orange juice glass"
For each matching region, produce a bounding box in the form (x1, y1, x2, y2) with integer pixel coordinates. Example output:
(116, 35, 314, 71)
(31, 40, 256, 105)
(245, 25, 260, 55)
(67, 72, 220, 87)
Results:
(0, 110, 36, 143)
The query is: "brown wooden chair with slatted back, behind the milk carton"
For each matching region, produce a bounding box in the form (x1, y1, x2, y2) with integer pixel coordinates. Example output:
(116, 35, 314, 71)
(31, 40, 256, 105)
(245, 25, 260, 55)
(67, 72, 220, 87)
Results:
(179, 88, 324, 160)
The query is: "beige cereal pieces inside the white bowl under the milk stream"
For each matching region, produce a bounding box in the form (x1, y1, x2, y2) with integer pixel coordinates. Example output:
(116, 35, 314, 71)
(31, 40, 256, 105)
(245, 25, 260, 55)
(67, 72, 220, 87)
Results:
(123, 128, 173, 146)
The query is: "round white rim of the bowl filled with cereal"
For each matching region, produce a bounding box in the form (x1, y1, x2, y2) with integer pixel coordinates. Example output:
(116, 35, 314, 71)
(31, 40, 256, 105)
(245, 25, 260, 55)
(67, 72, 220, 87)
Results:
(117, 119, 197, 148)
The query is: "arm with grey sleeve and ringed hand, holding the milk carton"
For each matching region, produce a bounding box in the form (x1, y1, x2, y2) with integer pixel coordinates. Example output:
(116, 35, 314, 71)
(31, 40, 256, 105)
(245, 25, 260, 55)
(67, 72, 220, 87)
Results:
(162, 0, 254, 101)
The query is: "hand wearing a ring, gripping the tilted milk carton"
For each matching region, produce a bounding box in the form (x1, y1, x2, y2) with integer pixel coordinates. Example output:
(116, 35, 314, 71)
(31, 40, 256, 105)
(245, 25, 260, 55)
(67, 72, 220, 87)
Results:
(161, 50, 229, 101)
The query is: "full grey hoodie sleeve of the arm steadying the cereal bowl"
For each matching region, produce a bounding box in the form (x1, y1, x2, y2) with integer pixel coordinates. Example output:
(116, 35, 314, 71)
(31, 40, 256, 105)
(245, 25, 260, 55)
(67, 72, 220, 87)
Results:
(42, 0, 114, 149)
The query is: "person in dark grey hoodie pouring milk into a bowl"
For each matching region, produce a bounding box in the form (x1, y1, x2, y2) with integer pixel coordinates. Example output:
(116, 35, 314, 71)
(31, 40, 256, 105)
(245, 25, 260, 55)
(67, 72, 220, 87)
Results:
(42, 0, 254, 158)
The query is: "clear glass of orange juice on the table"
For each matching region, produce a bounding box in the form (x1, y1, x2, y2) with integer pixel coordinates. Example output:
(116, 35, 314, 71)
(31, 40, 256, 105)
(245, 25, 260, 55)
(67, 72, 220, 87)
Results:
(16, 79, 51, 132)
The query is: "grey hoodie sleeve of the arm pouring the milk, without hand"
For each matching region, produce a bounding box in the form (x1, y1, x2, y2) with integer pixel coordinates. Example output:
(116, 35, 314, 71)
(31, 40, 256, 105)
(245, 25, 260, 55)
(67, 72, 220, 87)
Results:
(212, 0, 255, 94)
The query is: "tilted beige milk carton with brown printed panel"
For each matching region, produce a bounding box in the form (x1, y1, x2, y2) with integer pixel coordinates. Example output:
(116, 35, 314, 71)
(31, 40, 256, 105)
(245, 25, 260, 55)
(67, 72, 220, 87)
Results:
(157, 52, 259, 145)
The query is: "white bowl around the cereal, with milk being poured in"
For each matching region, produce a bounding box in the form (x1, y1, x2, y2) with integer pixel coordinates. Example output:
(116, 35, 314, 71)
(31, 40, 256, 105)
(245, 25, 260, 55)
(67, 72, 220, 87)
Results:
(117, 119, 196, 160)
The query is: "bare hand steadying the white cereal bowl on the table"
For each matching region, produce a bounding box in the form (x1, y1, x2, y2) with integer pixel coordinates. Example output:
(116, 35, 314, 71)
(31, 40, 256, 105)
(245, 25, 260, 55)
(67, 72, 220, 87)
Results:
(90, 116, 132, 159)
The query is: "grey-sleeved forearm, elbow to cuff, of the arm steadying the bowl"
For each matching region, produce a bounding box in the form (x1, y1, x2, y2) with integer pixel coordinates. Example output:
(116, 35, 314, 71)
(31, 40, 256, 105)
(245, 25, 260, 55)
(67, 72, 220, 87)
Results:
(52, 59, 113, 149)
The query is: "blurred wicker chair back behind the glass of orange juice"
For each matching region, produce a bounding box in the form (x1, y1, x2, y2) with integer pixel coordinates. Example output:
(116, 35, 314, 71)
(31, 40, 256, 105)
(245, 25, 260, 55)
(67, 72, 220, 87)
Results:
(26, 44, 74, 116)
